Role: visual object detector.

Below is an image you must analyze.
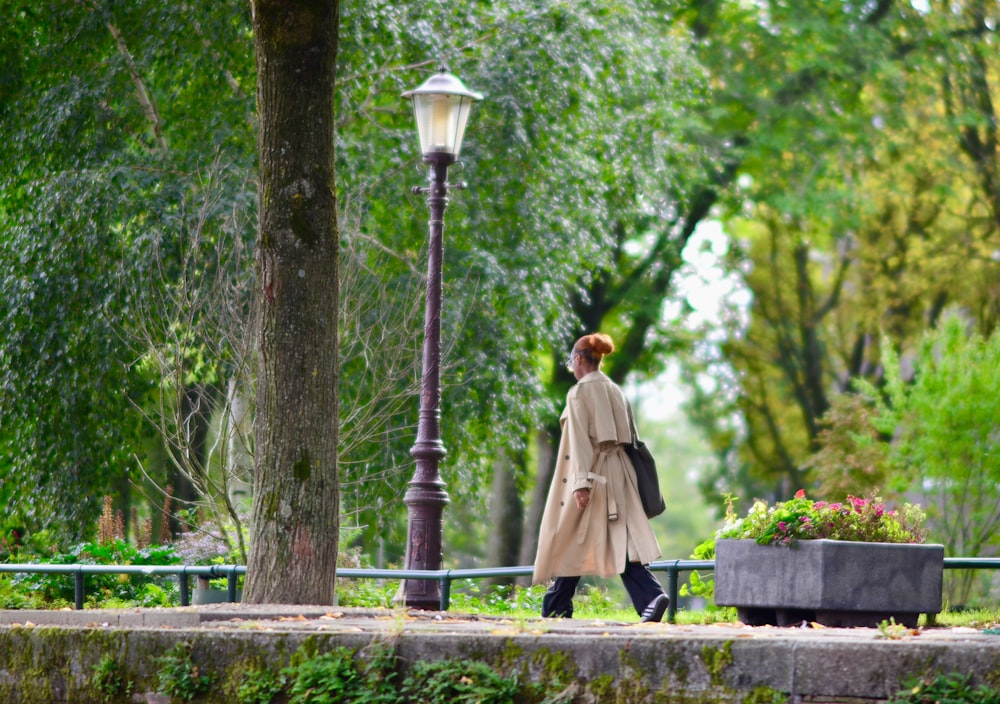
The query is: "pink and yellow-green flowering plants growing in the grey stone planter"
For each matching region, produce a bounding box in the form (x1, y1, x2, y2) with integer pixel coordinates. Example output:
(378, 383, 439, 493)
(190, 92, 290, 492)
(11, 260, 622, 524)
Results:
(716, 489, 925, 545)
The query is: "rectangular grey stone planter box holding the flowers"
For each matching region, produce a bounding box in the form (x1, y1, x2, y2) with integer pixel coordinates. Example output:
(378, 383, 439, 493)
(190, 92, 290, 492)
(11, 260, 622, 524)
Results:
(715, 540, 944, 628)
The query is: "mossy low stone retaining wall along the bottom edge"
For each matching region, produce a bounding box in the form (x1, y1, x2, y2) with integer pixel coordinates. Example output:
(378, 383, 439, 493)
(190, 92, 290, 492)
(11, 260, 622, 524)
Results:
(0, 622, 1000, 704)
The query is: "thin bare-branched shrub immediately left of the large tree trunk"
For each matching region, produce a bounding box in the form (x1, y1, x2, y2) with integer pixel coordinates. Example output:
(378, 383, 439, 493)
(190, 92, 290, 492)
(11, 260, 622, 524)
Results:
(129, 176, 254, 564)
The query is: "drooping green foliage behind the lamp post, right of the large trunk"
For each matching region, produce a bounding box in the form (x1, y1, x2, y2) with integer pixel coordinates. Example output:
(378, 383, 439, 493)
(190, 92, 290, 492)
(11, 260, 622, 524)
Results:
(338, 2, 706, 560)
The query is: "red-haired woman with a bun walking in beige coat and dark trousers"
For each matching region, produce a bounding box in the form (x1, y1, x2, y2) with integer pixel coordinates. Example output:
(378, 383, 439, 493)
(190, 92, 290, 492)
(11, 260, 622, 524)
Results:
(532, 333, 670, 621)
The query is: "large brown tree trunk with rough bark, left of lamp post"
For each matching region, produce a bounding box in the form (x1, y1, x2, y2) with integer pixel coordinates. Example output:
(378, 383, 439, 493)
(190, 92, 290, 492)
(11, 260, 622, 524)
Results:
(244, 0, 339, 604)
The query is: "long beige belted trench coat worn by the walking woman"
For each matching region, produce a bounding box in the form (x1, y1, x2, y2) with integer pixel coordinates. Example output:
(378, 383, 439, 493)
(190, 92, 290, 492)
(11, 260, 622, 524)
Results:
(532, 371, 660, 584)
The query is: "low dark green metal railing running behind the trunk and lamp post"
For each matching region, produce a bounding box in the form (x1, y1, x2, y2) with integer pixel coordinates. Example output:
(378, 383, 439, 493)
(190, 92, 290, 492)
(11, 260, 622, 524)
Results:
(0, 557, 1000, 623)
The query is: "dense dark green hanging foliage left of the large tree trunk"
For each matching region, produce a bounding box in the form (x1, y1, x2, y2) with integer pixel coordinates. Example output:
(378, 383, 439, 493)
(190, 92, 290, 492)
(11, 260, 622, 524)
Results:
(0, 0, 253, 537)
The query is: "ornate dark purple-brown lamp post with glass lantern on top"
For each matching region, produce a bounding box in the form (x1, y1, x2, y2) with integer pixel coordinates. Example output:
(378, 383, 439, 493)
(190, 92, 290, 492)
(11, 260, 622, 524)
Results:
(403, 68, 483, 610)
